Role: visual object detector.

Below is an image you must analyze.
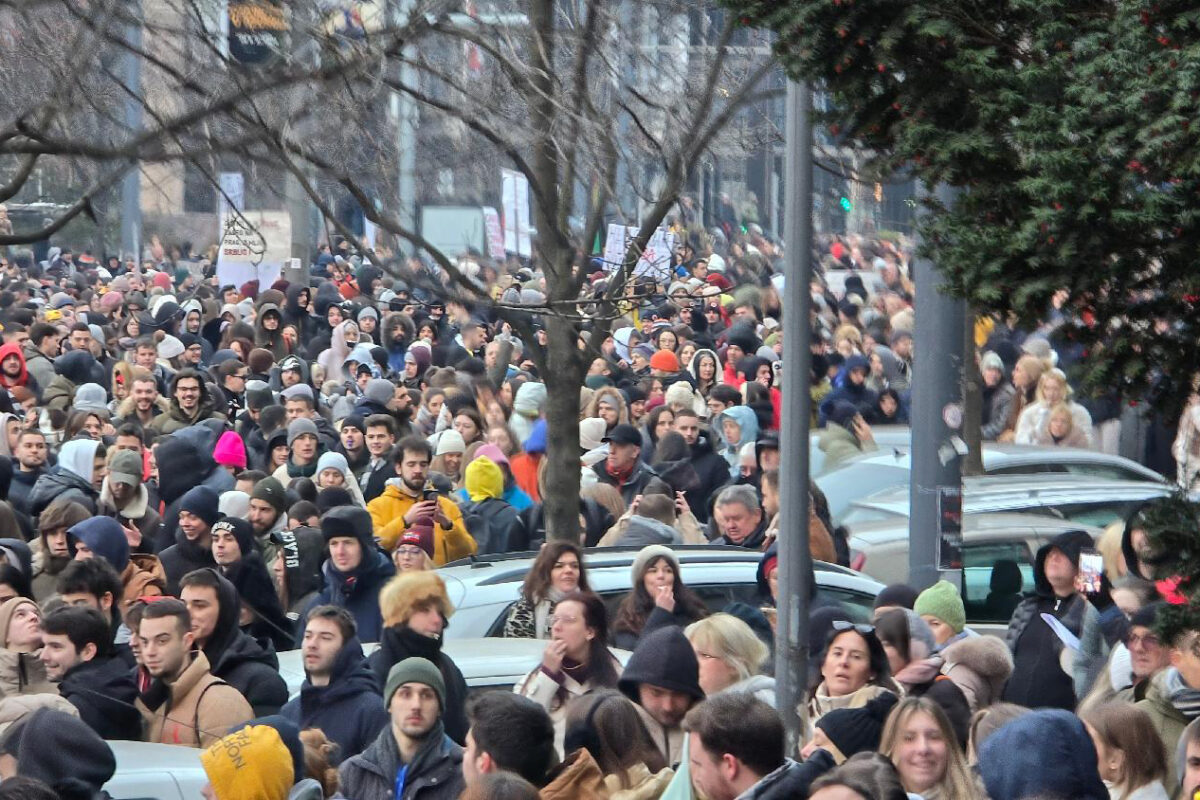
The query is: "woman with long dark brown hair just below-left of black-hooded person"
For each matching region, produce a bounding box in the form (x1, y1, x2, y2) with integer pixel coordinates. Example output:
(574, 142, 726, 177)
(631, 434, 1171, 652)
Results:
(564, 688, 674, 798)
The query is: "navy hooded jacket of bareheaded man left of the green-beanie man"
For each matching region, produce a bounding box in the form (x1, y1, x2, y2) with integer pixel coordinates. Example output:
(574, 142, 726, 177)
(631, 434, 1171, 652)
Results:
(280, 638, 391, 764)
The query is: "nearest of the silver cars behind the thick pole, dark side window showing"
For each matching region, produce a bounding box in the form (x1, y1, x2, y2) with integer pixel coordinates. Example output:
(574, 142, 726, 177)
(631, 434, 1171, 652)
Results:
(850, 513, 1102, 631)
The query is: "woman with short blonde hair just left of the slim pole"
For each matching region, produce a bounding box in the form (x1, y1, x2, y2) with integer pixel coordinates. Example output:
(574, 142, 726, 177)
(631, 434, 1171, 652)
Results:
(684, 613, 775, 708)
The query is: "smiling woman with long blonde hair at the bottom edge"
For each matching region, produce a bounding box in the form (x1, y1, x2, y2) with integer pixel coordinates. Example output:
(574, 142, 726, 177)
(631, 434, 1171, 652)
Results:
(880, 697, 979, 800)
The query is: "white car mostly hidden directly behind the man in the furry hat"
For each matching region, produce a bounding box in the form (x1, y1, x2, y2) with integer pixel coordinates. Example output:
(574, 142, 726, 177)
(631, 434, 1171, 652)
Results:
(278, 633, 632, 697)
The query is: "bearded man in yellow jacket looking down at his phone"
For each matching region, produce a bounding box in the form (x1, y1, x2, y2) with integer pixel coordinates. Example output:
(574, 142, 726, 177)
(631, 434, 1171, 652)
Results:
(367, 438, 476, 566)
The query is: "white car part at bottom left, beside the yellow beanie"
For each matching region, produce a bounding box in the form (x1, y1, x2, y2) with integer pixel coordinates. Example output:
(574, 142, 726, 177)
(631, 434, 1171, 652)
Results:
(104, 741, 209, 800)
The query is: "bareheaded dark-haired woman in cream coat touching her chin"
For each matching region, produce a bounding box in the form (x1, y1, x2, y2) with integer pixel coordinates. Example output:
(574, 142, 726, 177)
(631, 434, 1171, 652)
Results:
(512, 591, 620, 754)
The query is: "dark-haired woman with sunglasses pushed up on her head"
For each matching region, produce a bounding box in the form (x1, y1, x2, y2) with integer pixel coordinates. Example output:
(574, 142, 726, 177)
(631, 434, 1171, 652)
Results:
(809, 620, 901, 724)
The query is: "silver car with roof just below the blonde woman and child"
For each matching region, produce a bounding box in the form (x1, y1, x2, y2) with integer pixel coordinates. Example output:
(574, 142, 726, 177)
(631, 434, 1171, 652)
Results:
(814, 443, 1166, 524)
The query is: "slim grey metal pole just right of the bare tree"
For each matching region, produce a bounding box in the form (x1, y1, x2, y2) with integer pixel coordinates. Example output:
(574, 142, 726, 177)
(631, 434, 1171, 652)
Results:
(775, 82, 812, 757)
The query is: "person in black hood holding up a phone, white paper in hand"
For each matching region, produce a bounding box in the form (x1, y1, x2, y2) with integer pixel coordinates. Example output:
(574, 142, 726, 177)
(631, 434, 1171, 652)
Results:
(1003, 530, 1100, 711)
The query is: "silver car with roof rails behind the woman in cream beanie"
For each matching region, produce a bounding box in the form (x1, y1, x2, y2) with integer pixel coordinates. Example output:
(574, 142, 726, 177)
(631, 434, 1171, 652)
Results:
(438, 545, 883, 639)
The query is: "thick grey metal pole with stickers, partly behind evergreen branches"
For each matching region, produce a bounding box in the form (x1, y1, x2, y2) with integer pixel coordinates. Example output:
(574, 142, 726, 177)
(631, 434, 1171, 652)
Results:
(908, 186, 966, 589)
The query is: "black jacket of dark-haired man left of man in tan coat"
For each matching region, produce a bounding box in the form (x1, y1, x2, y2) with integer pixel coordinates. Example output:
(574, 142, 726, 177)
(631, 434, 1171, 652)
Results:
(59, 656, 142, 741)
